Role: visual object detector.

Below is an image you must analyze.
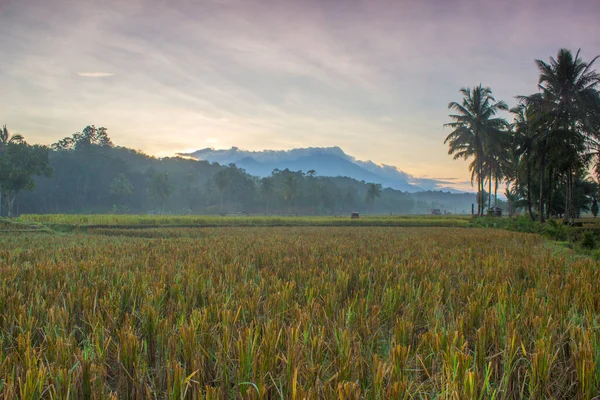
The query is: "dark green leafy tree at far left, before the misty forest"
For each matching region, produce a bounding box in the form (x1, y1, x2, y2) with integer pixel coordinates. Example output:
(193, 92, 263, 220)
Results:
(0, 131, 52, 217)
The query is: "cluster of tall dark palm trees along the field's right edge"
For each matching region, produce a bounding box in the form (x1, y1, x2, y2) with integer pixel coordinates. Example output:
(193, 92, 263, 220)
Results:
(444, 49, 600, 223)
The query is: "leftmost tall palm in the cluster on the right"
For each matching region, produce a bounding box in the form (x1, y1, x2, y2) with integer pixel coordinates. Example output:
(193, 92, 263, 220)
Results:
(444, 84, 508, 215)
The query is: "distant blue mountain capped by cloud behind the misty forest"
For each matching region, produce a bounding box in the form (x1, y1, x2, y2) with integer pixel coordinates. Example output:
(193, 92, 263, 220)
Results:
(178, 146, 458, 192)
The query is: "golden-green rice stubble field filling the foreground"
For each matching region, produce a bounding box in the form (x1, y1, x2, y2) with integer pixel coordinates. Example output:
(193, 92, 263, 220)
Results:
(0, 227, 600, 399)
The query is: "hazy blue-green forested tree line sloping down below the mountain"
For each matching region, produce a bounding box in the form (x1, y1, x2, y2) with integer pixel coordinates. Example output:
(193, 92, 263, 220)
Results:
(0, 125, 474, 215)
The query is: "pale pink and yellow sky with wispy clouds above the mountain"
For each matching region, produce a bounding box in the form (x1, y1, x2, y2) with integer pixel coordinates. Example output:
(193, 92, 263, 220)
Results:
(0, 0, 600, 189)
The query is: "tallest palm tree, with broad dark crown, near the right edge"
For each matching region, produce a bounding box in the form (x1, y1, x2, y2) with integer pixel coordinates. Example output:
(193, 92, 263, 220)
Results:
(521, 49, 600, 222)
